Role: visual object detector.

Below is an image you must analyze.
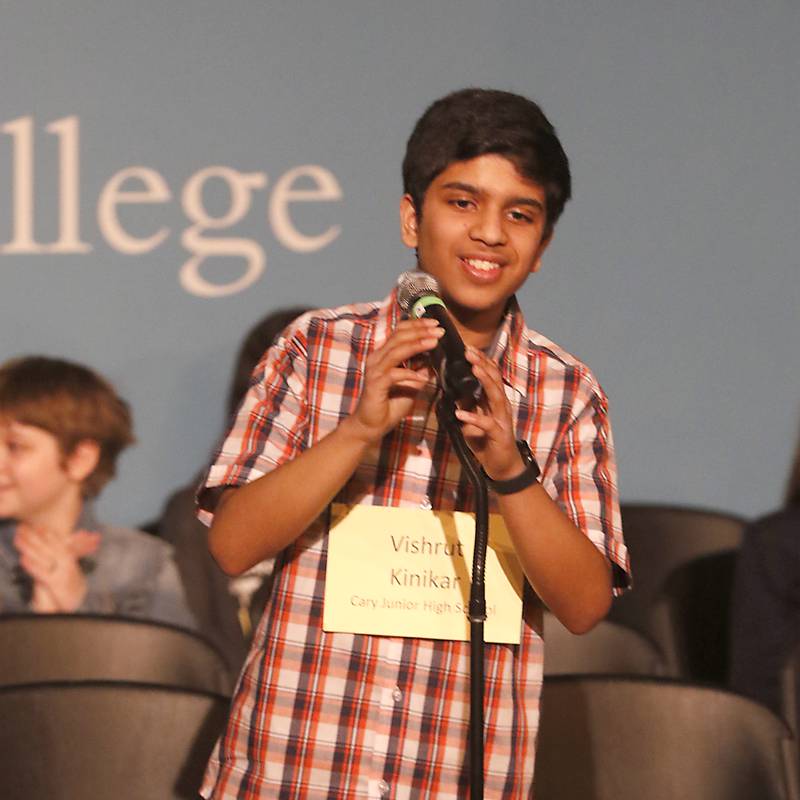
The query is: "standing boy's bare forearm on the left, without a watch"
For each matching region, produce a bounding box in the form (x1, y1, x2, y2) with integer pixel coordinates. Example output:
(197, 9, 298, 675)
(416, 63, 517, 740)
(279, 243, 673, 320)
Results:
(208, 418, 368, 575)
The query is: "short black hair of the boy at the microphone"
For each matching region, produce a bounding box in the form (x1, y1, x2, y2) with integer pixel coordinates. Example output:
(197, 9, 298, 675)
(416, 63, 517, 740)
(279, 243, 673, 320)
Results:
(403, 89, 572, 234)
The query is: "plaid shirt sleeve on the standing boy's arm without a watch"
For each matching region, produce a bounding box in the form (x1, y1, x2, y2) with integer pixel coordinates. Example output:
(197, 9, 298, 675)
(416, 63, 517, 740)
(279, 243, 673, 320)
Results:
(197, 322, 308, 525)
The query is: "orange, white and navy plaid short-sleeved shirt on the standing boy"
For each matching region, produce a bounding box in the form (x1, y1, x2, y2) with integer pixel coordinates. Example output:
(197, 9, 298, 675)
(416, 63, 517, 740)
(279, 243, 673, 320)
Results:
(200, 293, 628, 800)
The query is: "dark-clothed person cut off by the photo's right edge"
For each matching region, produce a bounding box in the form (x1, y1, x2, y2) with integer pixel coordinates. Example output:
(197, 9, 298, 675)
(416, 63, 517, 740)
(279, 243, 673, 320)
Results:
(730, 432, 800, 713)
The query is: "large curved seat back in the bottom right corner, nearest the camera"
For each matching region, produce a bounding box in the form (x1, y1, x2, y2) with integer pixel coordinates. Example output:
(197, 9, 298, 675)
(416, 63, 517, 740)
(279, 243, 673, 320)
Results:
(535, 676, 798, 800)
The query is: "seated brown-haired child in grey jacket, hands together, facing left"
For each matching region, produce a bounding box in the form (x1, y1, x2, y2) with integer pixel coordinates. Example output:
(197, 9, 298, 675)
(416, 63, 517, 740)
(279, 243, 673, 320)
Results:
(0, 356, 194, 628)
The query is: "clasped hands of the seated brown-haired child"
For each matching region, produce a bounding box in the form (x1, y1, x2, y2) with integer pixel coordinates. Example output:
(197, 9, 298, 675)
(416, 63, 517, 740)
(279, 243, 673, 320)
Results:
(14, 523, 90, 613)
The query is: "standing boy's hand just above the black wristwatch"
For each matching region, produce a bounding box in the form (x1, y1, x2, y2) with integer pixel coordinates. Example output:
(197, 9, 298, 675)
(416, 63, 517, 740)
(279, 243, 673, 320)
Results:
(456, 347, 524, 480)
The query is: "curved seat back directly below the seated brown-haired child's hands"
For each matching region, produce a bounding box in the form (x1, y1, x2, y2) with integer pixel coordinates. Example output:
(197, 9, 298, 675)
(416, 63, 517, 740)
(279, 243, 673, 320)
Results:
(0, 614, 231, 694)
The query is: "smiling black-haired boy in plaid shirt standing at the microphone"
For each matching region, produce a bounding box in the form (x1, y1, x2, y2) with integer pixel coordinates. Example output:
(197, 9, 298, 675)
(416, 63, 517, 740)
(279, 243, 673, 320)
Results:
(200, 89, 627, 800)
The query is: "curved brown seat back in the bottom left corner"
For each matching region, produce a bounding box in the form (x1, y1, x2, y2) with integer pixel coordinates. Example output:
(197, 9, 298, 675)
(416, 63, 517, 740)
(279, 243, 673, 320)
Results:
(0, 681, 228, 800)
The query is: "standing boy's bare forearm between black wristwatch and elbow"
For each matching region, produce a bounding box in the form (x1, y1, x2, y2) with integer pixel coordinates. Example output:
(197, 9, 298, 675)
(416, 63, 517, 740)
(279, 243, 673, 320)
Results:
(498, 483, 612, 633)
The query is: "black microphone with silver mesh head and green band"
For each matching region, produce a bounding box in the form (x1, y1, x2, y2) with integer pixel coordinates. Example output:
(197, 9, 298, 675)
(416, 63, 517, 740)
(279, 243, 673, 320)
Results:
(397, 270, 481, 410)
